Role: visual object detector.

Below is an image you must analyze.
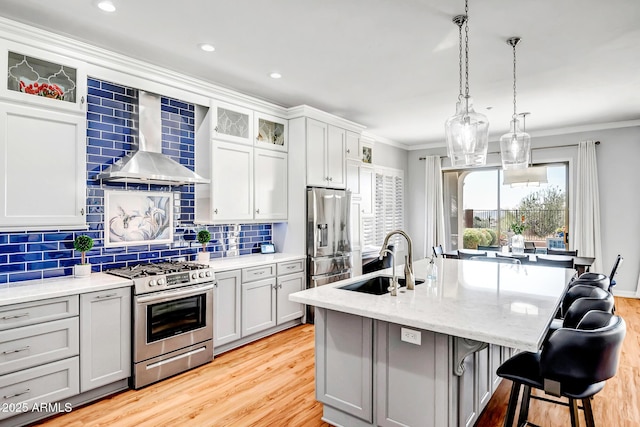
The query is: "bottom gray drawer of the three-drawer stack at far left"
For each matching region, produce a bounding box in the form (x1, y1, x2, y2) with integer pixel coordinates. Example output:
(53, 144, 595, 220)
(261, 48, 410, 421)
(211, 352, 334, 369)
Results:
(0, 356, 80, 419)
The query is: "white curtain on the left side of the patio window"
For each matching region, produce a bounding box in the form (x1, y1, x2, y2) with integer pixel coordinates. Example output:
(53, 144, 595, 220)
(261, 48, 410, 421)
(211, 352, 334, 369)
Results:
(424, 156, 447, 257)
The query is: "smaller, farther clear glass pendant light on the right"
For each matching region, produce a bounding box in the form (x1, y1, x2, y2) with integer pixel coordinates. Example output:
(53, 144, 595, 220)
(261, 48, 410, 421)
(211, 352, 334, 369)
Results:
(500, 37, 531, 170)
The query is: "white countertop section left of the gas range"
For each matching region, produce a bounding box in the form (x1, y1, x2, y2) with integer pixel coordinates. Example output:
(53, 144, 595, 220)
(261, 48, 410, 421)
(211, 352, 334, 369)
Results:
(0, 273, 133, 307)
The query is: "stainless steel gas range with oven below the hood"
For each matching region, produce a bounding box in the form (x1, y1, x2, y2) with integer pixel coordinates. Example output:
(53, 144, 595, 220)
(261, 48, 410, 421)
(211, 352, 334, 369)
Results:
(106, 262, 215, 389)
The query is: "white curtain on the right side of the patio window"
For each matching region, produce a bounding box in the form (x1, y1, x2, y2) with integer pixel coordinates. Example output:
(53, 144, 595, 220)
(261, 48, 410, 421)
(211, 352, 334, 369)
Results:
(569, 141, 603, 273)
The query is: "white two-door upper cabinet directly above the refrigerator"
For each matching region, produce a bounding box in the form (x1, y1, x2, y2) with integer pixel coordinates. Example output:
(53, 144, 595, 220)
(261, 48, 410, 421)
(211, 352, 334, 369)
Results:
(307, 119, 346, 188)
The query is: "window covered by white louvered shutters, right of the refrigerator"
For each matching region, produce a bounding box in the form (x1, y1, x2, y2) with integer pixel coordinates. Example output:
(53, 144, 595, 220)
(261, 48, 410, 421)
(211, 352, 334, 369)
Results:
(362, 168, 404, 249)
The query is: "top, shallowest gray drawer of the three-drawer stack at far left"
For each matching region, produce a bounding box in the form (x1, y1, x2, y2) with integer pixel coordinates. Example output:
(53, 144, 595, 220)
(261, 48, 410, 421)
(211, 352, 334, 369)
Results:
(0, 295, 80, 331)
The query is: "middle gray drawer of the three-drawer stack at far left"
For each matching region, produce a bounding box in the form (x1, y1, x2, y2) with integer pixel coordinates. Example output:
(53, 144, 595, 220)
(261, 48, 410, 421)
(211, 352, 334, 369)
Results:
(0, 317, 80, 375)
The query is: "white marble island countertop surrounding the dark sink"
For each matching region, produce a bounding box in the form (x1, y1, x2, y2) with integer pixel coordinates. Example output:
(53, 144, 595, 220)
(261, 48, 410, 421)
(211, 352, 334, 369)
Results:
(289, 258, 575, 351)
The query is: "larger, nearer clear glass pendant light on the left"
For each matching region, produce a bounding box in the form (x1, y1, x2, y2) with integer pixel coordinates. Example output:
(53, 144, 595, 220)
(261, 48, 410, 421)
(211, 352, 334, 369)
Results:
(445, 0, 489, 167)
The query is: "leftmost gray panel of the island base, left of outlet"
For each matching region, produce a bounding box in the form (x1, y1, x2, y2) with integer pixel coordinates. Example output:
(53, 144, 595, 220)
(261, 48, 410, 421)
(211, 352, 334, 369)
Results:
(315, 307, 373, 425)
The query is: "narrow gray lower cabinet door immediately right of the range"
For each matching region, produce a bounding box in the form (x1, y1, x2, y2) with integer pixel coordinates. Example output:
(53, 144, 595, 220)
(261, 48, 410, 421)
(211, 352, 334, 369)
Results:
(213, 270, 242, 350)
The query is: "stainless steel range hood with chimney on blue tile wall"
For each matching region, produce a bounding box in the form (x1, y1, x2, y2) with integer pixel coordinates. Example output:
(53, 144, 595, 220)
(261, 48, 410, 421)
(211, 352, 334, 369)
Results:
(96, 91, 210, 185)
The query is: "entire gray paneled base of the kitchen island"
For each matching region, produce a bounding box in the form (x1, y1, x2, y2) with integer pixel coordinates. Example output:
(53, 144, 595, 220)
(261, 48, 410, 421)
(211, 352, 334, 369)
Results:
(315, 307, 512, 427)
